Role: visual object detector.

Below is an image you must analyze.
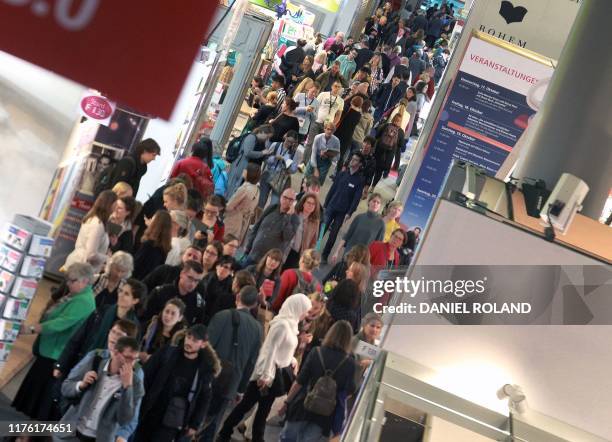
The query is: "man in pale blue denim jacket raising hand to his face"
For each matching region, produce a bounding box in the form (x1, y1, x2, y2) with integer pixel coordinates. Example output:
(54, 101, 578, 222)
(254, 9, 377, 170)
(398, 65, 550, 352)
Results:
(53, 336, 144, 442)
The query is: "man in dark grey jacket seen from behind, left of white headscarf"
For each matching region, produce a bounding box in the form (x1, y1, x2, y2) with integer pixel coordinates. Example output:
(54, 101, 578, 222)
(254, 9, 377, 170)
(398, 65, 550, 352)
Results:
(199, 285, 263, 442)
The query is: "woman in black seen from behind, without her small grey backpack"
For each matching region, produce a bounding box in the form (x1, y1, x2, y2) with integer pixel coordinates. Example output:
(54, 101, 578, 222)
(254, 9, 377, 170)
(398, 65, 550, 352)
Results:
(281, 321, 356, 440)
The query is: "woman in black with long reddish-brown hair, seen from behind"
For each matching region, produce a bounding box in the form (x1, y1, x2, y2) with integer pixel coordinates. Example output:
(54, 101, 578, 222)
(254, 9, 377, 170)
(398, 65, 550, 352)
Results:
(134, 210, 172, 280)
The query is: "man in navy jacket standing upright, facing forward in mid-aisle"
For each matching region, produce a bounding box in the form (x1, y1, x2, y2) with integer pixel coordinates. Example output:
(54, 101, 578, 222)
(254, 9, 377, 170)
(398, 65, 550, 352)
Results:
(322, 152, 364, 261)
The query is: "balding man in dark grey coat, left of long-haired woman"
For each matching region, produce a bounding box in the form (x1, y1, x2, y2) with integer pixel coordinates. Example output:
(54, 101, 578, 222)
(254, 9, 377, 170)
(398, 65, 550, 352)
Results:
(243, 189, 300, 267)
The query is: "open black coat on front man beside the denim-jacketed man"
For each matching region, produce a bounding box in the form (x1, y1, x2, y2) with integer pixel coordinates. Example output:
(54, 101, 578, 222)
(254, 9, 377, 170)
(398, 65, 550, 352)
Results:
(140, 343, 220, 428)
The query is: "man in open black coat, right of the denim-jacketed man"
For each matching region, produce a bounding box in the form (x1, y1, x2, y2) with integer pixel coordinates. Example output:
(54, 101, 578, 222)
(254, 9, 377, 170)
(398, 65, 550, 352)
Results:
(136, 324, 221, 442)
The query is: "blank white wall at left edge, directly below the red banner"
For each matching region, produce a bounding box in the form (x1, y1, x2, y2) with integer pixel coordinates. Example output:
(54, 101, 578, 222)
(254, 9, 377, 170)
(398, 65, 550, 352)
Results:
(0, 52, 85, 223)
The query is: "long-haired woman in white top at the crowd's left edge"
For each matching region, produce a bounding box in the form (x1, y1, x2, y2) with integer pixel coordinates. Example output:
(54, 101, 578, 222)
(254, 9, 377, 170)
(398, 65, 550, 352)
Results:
(63, 190, 117, 273)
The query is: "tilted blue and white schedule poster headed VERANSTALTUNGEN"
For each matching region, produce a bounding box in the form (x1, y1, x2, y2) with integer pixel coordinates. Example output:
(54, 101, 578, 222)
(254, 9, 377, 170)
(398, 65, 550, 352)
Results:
(401, 37, 553, 228)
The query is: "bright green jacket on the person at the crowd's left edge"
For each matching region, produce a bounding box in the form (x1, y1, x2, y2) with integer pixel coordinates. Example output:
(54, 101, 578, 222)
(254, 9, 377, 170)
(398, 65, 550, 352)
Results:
(38, 286, 96, 360)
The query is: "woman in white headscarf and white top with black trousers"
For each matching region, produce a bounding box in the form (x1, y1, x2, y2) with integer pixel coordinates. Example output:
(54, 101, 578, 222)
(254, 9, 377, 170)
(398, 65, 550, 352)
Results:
(217, 294, 312, 442)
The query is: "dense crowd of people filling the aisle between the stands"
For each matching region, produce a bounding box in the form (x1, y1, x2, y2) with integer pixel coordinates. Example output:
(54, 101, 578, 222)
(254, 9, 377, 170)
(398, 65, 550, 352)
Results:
(13, 3, 452, 442)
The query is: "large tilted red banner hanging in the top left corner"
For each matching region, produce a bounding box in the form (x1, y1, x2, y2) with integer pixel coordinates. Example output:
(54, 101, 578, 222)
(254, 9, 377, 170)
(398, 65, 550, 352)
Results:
(0, 0, 218, 118)
